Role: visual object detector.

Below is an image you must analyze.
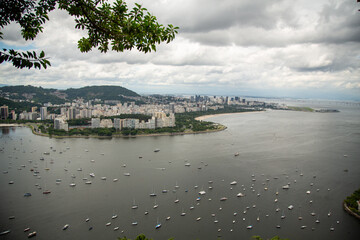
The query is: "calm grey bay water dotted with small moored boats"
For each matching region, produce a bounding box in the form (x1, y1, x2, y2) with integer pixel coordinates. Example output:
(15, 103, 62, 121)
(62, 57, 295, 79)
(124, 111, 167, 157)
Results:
(0, 101, 360, 240)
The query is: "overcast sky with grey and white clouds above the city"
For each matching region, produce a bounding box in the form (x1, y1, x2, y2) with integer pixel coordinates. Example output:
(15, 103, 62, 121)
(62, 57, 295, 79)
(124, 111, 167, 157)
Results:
(0, 0, 360, 100)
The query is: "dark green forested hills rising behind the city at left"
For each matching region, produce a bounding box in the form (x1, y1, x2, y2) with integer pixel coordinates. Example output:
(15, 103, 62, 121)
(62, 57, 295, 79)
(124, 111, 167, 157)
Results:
(0, 85, 140, 104)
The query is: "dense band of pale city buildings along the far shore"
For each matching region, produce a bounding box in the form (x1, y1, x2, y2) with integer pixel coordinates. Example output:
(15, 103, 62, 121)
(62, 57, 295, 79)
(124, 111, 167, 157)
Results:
(1, 95, 267, 131)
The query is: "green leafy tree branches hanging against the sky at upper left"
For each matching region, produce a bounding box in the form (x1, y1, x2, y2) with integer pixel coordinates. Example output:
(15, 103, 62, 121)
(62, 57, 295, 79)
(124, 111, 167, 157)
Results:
(0, 0, 178, 69)
